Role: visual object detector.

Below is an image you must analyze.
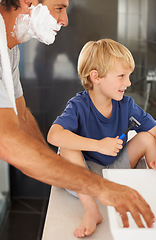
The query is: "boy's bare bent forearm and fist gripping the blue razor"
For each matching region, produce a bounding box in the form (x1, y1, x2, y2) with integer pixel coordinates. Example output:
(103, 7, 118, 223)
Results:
(47, 124, 123, 156)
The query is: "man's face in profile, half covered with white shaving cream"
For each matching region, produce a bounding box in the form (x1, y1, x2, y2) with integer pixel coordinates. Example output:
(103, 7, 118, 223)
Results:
(13, 0, 69, 45)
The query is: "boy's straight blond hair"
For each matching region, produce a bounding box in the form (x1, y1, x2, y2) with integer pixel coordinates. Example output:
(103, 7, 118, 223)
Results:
(78, 39, 135, 90)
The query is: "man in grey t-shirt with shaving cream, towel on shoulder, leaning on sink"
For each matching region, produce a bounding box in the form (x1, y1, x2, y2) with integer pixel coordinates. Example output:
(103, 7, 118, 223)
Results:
(0, 0, 154, 231)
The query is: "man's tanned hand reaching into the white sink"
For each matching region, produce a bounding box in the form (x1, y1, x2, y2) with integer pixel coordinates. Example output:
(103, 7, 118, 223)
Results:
(98, 180, 155, 228)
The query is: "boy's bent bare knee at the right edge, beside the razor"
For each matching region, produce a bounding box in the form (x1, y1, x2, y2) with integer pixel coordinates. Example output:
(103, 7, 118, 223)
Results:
(127, 132, 156, 168)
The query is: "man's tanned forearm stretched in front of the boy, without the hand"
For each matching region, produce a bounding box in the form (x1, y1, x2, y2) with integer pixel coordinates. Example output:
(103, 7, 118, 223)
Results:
(0, 107, 101, 195)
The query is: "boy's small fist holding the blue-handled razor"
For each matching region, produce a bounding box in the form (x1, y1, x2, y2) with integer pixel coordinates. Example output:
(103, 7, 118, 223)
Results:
(98, 136, 123, 156)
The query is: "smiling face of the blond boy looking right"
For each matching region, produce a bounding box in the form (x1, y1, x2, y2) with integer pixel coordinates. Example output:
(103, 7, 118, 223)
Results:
(100, 61, 132, 101)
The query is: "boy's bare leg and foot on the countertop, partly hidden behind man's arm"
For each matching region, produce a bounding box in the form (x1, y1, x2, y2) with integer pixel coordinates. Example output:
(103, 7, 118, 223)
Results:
(60, 148, 102, 238)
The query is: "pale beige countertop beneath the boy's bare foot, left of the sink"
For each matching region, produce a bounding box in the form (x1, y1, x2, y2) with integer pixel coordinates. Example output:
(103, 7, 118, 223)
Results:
(42, 187, 113, 240)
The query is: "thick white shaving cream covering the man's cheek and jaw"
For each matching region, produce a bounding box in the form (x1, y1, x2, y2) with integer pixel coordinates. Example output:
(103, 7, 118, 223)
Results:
(13, 3, 61, 45)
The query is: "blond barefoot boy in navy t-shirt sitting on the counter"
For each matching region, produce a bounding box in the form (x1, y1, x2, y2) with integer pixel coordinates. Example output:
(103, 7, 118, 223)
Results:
(48, 39, 156, 237)
